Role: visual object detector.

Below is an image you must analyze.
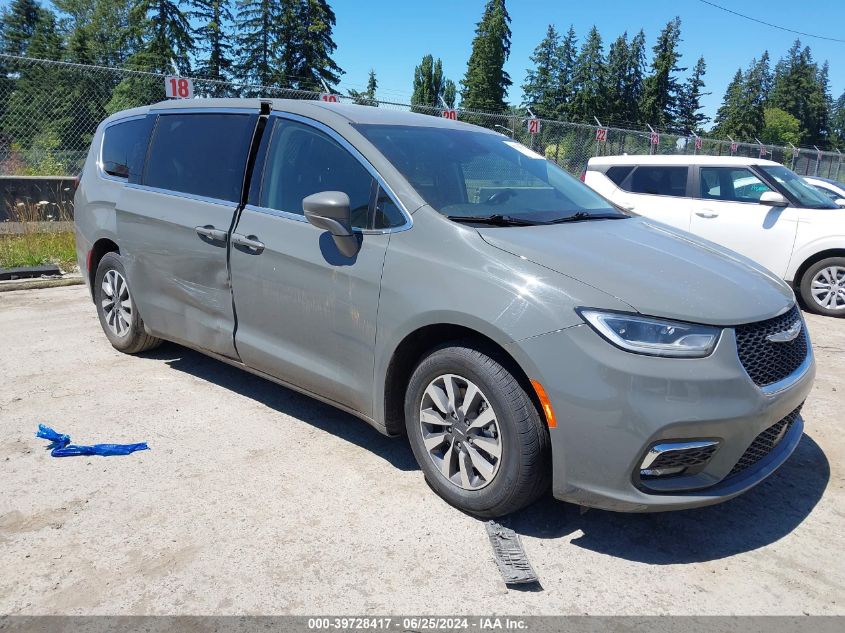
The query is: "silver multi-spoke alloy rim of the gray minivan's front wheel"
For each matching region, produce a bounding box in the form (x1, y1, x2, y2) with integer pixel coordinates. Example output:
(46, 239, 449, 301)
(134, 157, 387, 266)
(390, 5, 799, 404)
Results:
(420, 374, 503, 490)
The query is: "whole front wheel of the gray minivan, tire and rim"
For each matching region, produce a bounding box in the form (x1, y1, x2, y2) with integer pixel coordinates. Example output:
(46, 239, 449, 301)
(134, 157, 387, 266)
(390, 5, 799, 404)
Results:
(405, 342, 550, 517)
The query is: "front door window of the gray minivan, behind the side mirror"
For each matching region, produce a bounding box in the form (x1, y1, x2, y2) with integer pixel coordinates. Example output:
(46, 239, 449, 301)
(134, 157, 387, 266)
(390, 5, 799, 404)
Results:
(259, 119, 373, 228)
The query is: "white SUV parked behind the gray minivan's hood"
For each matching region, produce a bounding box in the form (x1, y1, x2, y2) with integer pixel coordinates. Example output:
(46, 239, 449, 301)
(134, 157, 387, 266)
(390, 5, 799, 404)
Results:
(584, 156, 845, 317)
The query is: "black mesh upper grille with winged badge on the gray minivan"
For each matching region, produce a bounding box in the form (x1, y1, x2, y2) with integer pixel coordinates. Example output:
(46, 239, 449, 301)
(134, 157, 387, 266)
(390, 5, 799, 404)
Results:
(735, 306, 807, 387)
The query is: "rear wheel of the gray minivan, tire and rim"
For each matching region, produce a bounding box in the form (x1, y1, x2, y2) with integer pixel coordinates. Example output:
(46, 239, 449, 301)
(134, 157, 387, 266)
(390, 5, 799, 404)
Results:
(94, 253, 161, 354)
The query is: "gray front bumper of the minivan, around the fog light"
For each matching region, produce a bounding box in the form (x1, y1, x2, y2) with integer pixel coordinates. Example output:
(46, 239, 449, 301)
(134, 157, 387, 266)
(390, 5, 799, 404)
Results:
(510, 318, 815, 512)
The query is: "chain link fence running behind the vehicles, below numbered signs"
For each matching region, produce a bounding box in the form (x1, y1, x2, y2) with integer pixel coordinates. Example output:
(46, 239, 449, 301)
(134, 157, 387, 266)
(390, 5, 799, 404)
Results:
(0, 54, 845, 180)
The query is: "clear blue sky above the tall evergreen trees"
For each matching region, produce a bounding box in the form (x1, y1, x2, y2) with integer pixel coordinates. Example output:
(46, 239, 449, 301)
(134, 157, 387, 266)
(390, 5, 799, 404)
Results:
(331, 0, 845, 124)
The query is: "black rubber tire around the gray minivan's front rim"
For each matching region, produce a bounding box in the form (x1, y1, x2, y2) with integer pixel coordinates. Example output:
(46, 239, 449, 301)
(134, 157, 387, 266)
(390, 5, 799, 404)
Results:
(405, 341, 551, 518)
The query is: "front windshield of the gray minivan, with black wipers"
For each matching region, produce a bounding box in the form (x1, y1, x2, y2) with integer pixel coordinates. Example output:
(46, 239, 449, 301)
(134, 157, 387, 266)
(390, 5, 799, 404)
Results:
(356, 125, 625, 224)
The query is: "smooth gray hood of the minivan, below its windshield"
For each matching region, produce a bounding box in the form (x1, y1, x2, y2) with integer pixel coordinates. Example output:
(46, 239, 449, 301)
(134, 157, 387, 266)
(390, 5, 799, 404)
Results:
(478, 218, 795, 326)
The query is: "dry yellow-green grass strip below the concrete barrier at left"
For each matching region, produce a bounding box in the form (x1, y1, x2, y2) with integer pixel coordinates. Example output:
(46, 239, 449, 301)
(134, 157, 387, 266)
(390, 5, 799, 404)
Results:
(0, 202, 76, 272)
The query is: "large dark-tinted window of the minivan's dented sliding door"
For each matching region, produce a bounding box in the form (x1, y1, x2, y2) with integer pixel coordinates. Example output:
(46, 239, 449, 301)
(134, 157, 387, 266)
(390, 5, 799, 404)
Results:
(144, 114, 255, 202)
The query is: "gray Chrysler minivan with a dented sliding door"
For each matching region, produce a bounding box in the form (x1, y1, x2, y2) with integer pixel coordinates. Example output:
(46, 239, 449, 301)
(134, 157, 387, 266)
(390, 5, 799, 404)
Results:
(75, 99, 815, 516)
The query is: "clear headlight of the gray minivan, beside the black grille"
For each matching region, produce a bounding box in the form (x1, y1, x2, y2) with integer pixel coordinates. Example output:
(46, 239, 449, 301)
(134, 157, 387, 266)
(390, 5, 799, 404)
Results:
(578, 308, 722, 358)
